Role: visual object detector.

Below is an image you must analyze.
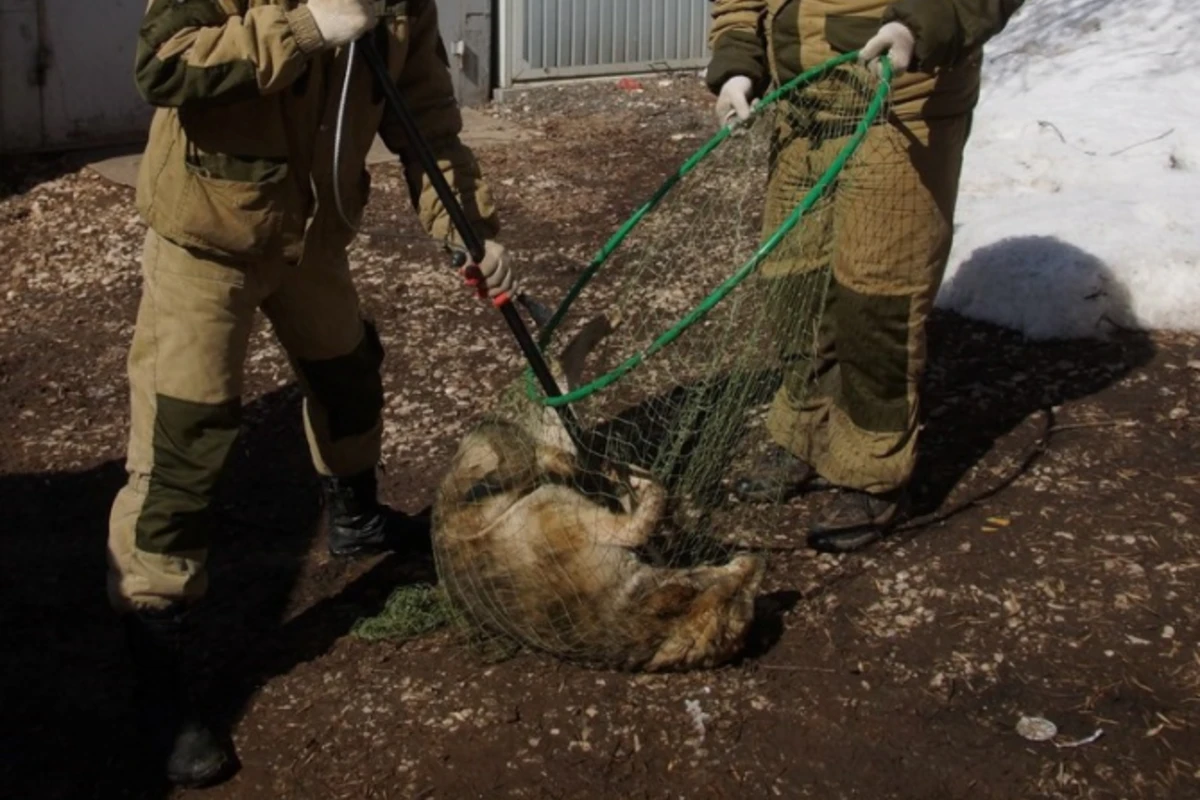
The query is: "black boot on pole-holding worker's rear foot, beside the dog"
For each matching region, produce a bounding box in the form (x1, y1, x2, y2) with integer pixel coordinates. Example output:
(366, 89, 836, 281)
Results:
(320, 469, 428, 558)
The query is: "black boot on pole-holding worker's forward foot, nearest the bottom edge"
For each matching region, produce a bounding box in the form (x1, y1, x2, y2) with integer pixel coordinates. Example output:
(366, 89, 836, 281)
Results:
(121, 610, 236, 788)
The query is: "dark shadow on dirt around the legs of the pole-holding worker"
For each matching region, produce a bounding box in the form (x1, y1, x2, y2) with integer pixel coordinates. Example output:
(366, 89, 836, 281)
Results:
(0, 389, 432, 800)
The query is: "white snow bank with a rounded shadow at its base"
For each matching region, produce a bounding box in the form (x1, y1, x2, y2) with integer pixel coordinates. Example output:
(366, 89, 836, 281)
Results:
(937, 0, 1200, 338)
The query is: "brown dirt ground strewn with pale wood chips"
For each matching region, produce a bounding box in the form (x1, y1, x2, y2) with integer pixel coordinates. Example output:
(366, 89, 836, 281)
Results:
(0, 76, 1200, 800)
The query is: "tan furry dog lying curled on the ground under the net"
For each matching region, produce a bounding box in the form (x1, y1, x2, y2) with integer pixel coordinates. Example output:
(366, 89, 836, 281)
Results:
(432, 317, 764, 672)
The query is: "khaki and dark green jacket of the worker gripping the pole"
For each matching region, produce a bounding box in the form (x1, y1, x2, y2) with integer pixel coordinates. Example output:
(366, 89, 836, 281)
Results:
(136, 0, 498, 260)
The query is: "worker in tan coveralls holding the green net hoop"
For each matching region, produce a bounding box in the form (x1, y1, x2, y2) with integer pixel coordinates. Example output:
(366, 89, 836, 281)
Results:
(707, 0, 1024, 552)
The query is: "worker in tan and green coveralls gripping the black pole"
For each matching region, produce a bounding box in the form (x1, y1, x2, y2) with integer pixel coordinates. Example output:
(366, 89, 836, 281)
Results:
(109, 0, 512, 786)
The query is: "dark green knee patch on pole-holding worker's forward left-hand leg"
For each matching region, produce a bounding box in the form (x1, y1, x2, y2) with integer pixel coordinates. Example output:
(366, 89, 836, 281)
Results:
(136, 395, 241, 554)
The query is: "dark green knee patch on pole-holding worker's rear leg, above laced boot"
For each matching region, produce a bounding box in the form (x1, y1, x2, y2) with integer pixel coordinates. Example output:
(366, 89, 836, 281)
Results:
(299, 321, 383, 441)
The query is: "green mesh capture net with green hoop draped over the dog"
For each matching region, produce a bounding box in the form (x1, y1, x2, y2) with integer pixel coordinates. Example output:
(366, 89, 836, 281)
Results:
(434, 53, 902, 667)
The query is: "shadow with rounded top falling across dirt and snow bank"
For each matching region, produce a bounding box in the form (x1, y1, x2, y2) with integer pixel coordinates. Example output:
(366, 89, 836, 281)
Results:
(913, 237, 1156, 515)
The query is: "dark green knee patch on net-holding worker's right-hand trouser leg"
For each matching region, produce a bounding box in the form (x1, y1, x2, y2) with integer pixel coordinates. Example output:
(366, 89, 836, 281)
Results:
(834, 284, 912, 433)
